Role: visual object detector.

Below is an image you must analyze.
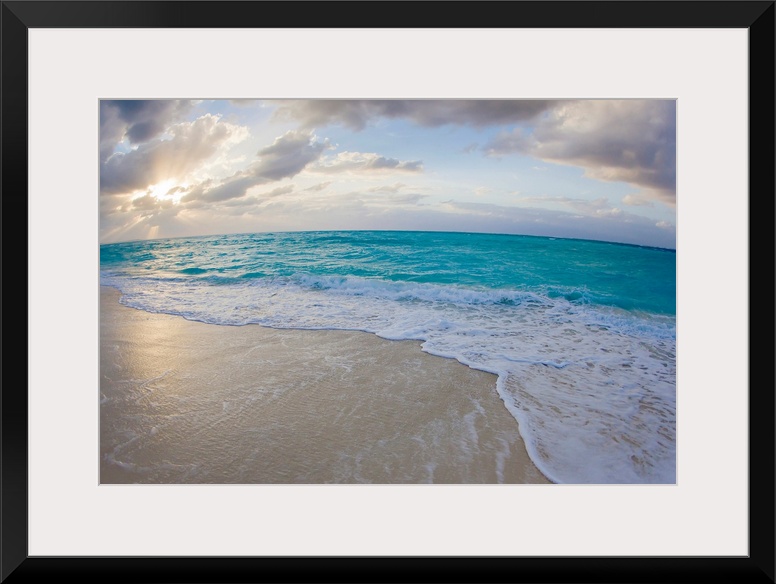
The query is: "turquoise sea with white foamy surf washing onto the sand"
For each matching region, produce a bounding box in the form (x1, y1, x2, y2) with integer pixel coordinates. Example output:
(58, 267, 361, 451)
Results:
(100, 231, 676, 483)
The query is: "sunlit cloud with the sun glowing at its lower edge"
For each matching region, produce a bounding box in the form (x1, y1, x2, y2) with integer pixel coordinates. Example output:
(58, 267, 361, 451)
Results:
(100, 114, 237, 195)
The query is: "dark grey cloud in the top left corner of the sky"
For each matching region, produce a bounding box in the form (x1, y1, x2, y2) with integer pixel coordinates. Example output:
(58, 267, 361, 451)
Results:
(100, 99, 192, 162)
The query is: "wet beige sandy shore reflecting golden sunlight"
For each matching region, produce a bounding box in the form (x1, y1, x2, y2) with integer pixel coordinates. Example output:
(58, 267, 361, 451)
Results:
(100, 287, 548, 484)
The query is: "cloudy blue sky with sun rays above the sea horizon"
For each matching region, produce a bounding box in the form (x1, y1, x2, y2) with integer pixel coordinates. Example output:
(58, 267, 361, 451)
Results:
(99, 99, 676, 249)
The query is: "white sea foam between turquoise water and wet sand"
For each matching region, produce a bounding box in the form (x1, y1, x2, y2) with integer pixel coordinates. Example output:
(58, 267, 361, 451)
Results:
(102, 273, 676, 483)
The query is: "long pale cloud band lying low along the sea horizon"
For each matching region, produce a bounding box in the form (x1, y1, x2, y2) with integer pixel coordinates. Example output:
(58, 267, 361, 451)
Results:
(101, 187, 676, 248)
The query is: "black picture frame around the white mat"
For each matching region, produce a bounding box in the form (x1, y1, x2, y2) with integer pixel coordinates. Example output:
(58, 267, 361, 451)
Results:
(0, 0, 776, 583)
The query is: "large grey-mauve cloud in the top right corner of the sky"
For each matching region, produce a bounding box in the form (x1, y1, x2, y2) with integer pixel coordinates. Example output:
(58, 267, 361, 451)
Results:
(484, 100, 676, 205)
